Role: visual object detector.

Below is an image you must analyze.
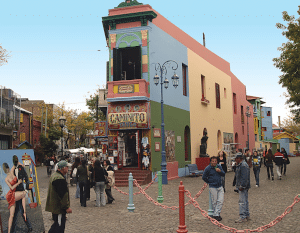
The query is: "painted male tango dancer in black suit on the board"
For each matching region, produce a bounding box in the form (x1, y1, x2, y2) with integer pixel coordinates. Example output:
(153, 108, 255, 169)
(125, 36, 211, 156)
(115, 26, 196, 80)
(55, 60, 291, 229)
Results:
(11, 155, 32, 233)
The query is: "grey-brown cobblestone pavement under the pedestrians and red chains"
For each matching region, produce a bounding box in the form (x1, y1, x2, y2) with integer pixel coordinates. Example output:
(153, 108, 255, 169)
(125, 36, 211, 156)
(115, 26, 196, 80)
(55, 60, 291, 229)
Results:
(37, 157, 300, 233)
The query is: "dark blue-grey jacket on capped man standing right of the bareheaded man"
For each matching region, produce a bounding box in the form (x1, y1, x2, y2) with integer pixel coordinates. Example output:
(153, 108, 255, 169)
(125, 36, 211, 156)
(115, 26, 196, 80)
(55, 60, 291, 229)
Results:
(235, 160, 251, 189)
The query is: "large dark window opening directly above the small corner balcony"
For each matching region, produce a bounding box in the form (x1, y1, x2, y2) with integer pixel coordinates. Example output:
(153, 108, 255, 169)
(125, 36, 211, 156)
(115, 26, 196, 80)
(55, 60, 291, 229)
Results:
(113, 46, 141, 81)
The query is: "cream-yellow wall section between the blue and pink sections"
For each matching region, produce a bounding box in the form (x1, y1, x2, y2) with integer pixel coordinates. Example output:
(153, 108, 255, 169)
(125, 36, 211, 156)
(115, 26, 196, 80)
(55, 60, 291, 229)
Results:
(188, 49, 234, 163)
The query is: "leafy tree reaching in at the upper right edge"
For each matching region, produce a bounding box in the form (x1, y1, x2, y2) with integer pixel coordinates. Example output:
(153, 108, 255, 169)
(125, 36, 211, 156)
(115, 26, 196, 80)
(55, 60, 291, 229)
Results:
(273, 6, 300, 122)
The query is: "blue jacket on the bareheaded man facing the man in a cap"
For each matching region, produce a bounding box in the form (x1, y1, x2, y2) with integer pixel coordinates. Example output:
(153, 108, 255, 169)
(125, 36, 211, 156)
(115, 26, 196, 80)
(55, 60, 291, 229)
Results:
(202, 164, 225, 188)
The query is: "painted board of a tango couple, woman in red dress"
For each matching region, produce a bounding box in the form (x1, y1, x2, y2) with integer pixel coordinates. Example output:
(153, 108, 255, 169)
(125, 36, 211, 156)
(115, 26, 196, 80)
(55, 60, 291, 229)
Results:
(0, 149, 45, 232)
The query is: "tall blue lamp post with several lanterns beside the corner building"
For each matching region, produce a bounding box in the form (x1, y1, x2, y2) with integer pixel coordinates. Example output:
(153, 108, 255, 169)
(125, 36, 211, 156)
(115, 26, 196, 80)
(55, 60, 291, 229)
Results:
(153, 60, 179, 184)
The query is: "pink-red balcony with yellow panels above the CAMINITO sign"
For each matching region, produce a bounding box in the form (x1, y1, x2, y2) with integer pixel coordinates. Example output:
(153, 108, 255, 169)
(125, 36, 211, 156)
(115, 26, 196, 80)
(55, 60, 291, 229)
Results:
(107, 79, 150, 102)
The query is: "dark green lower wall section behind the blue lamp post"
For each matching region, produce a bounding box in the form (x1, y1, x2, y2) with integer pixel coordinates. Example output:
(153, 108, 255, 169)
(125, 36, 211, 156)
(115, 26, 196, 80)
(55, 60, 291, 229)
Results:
(150, 101, 191, 172)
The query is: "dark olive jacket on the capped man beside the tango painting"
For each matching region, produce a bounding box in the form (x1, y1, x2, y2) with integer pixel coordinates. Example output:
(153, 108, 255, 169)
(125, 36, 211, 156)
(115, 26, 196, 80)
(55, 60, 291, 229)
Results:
(45, 171, 70, 214)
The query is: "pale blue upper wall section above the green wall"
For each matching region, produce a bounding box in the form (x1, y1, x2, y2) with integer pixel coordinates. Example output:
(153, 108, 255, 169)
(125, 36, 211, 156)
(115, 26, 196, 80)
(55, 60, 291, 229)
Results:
(149, 22, 190, 111)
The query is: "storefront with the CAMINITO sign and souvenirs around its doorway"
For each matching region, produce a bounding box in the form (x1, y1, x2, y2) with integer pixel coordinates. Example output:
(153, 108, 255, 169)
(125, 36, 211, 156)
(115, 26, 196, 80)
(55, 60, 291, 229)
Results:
(107, 101, 150, 169)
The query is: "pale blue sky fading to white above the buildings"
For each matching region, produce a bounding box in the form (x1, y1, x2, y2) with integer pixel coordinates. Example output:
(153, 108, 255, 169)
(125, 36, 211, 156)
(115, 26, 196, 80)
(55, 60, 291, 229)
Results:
(0, 0, 300, 124)
